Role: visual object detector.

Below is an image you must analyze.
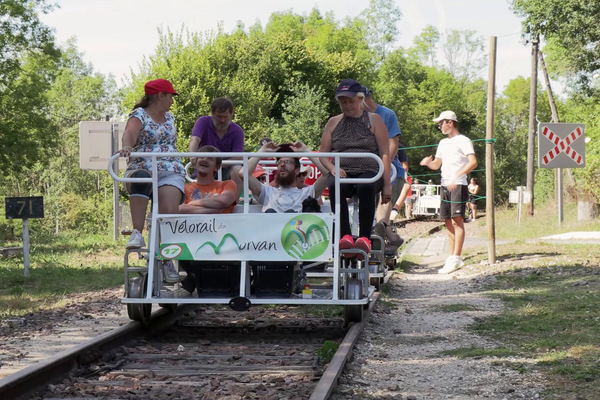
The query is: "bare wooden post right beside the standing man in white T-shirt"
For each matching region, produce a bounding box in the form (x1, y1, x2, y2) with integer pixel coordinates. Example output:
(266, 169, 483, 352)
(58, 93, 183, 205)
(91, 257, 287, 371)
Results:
(485, 36, 496, 264)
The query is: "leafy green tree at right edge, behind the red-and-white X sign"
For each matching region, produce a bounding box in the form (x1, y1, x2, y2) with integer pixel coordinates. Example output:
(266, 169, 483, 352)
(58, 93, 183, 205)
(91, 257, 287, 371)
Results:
(512, 0, 600, 201)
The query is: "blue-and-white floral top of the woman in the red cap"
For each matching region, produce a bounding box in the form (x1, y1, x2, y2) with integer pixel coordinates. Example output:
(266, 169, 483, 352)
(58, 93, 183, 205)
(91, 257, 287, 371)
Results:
(127, 107, 185, 174)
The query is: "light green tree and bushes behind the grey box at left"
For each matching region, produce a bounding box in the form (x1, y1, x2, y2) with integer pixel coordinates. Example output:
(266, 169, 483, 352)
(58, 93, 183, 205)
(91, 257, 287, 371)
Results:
(0, 39, 118, 233)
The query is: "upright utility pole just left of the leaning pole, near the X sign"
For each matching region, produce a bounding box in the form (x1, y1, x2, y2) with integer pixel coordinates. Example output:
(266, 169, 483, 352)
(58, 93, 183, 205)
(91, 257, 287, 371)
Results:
(527, 34, 540, 216)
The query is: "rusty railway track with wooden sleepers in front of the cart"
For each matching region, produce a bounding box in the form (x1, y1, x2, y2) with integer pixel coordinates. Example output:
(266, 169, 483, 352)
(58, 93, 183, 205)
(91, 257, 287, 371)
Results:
(0, 297, 376, 400)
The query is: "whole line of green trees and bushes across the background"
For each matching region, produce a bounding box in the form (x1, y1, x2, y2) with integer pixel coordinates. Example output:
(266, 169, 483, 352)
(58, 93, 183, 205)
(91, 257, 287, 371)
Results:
(0, 0, 600, 238)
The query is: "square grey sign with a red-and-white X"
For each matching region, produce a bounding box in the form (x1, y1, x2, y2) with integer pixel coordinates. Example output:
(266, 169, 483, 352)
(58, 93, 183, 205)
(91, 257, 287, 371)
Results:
(538, 123, 585, 168)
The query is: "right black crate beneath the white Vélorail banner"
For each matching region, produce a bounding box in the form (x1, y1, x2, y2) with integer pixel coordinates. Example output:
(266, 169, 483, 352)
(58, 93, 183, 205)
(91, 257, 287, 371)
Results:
(248, 261, 296, 298)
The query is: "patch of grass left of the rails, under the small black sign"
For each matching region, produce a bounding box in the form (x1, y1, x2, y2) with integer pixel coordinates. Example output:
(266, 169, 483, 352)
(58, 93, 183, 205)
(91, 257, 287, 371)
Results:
(0, 235, 124, 318)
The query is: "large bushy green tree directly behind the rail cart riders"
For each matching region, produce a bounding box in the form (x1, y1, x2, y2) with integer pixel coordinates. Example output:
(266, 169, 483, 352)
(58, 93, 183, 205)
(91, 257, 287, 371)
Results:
(123, 10, 374, 150)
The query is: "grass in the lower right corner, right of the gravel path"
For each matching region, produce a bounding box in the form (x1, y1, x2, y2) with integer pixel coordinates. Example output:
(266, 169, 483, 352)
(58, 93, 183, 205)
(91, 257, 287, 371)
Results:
(474, 243, 600, 399)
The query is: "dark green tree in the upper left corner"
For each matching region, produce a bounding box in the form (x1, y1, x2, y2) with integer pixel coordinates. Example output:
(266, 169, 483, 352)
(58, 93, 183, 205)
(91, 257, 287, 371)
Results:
(0, 0, 59, 171)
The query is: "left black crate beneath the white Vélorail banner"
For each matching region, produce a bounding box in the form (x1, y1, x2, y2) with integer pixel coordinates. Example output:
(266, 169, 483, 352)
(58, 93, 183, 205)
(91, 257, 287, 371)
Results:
(179, 261, 241, 298)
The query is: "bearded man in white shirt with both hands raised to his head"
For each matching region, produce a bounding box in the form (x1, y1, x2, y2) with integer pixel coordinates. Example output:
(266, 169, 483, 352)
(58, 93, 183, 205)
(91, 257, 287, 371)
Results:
(239, 142, 327, 213)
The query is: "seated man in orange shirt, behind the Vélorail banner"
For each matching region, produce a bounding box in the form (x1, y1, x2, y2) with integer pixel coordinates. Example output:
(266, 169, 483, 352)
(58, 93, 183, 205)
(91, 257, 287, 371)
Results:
(179, 146, 237, 214)
